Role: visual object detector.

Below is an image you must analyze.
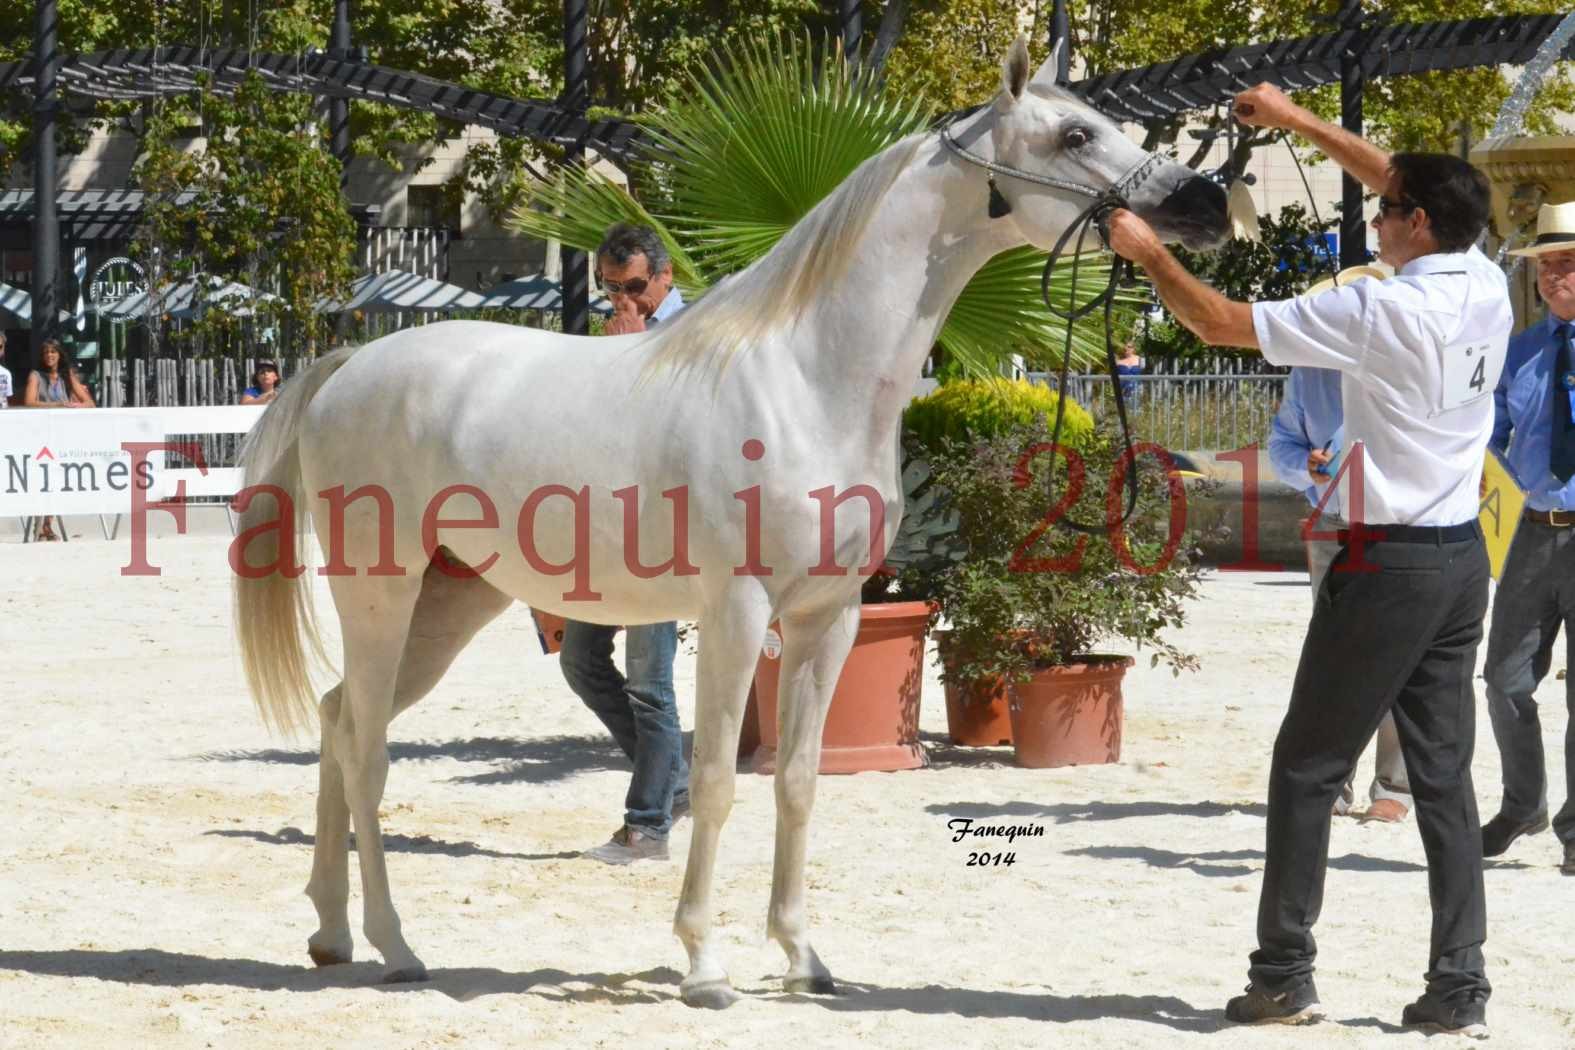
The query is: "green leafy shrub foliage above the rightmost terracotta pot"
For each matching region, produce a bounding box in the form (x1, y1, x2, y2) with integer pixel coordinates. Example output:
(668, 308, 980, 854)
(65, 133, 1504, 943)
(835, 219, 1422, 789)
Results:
(929, 419, 1199, 693)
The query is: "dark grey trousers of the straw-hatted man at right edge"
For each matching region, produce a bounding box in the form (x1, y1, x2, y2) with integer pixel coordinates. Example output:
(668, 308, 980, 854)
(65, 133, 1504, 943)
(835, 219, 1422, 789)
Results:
(1484, 521, 1575, 842)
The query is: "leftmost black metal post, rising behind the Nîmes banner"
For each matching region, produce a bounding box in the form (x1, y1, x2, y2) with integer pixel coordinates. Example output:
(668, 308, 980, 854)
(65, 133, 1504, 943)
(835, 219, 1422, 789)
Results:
(33, 0, 60, 364)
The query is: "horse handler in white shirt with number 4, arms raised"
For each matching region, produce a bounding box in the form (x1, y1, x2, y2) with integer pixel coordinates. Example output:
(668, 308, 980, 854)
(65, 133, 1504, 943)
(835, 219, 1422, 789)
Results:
(1110, 83, 1512, 1036)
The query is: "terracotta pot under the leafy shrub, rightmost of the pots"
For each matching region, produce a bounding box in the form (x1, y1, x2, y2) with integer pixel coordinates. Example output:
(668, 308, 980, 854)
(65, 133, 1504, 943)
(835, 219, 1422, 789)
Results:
(1008, 656, 1132, 770)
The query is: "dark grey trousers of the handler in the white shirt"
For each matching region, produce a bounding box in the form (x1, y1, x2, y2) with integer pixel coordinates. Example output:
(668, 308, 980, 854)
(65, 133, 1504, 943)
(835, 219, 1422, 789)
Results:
(1251, 531, 1490, 1000)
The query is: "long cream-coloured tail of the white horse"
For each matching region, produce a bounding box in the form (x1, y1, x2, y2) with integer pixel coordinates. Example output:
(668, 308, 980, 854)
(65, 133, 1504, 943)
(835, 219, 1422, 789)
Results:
(230, 346, 359, 732)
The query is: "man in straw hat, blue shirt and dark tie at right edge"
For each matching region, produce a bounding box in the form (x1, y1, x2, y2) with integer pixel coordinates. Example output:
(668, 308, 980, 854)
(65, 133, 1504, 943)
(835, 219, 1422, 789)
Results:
(1482, 203, 1575, 875)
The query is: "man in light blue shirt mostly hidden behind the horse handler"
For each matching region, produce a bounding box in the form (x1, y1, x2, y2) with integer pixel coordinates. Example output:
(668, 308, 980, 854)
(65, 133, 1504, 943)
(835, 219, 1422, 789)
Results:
(1268, 367, 1411, 823)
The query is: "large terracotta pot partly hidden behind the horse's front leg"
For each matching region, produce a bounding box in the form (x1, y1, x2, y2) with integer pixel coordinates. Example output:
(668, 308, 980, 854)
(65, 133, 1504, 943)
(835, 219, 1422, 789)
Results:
(754, 601, 929, 773)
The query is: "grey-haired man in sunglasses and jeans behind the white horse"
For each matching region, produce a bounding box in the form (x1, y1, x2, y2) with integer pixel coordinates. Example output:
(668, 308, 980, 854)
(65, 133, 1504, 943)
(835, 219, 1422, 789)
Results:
(558, 222, 690, 864)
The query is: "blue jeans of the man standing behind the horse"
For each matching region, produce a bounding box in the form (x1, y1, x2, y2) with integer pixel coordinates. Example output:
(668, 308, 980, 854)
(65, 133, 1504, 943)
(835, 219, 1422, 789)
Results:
(558, 620, 688, 837)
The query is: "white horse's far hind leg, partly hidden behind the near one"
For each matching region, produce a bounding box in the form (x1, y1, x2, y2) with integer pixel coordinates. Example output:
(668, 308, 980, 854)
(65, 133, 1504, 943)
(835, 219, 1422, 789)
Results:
(306, 564, 512, 967)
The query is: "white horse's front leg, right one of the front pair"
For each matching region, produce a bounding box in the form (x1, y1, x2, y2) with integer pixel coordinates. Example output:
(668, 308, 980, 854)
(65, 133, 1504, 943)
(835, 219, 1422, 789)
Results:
(765, 604, 858, 993)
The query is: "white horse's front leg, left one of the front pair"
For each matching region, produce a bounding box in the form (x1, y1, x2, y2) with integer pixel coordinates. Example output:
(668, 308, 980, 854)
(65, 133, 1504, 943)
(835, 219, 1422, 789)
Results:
(673, 581, 770, 1009)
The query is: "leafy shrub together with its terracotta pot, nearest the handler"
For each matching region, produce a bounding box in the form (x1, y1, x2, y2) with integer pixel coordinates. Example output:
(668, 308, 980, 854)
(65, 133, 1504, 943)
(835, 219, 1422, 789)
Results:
(928, 398, 1199, 767)
